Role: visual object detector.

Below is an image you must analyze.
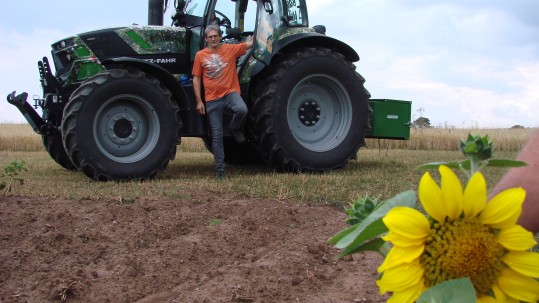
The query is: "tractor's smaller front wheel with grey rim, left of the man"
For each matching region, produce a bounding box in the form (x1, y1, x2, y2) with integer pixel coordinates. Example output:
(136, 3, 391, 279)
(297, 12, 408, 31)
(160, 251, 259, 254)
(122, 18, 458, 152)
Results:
(62, 69, 181, 181)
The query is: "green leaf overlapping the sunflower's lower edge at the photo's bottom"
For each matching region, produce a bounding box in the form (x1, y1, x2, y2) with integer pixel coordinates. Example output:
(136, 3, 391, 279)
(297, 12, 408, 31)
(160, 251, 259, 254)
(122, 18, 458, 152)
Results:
(416, 278, 476, 303)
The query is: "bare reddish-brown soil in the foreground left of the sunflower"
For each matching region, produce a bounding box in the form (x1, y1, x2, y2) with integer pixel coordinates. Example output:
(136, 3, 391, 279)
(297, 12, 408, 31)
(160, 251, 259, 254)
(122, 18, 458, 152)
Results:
(0, 192, 387, 303)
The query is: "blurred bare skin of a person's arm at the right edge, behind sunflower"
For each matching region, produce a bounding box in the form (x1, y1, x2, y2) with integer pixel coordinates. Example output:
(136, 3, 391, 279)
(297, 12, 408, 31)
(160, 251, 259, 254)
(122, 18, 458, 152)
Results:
(490, 131, 539, 233)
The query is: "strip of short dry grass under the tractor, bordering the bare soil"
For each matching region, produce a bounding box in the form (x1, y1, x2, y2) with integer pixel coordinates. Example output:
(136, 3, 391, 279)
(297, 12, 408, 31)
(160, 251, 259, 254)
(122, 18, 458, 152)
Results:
(0, 149, 516, 207)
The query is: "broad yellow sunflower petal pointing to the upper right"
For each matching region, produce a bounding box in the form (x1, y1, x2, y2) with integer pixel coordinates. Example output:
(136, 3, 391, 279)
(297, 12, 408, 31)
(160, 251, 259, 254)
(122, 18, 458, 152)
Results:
(479, 187, 526, 228)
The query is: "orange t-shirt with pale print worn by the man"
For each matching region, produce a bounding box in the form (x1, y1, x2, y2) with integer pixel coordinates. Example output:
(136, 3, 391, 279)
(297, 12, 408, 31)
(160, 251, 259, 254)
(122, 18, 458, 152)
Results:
(193, 43, 247, 101)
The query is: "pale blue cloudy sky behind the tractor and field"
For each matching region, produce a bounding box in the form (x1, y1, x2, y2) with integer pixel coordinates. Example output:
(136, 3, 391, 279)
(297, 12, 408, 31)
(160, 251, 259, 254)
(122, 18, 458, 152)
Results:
(0, 0, 539, 128)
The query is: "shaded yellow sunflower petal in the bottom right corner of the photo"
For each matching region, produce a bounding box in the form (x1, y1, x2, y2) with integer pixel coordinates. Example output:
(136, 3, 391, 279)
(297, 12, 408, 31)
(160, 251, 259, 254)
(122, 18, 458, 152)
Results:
(498, 268, 539, 302)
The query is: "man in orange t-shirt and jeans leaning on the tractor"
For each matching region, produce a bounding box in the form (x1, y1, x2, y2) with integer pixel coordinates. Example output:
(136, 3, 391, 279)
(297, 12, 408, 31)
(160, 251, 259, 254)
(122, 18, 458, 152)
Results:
(193, 25, 253, 179)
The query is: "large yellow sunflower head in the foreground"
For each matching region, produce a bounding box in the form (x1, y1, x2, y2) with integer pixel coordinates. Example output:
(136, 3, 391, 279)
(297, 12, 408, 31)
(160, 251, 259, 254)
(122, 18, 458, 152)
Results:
(376, 166, 539, 303)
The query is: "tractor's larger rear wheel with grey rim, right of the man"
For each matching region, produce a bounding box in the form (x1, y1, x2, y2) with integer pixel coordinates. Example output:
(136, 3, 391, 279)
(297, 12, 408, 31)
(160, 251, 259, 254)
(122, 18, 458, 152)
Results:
(246, 48, 371, 172)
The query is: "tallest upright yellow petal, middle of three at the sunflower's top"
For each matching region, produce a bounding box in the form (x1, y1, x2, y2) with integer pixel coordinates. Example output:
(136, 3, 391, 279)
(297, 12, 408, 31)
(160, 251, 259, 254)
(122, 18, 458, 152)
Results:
(439, 165, 464, 219)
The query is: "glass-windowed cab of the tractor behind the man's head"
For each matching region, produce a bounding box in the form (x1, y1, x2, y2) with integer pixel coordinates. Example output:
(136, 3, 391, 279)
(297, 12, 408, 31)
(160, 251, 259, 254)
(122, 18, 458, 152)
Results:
(172, 0, 314, 64)
